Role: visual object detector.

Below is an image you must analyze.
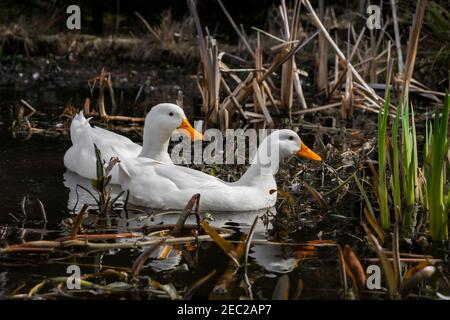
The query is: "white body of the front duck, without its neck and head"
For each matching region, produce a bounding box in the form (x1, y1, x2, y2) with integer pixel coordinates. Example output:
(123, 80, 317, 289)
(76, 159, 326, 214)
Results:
(119, 158, 276, 211)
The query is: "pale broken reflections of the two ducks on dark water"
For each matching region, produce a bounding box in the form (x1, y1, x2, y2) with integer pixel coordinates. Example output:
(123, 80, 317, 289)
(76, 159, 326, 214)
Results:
(64, 170, 297, 274)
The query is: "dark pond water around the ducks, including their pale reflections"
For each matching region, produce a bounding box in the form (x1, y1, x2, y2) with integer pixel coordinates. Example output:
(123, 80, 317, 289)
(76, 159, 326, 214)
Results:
(0, 74, 370, 299)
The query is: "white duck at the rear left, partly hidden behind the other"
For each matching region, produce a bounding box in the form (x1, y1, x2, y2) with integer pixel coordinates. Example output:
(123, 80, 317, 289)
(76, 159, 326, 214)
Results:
(64, 103, 203, 184)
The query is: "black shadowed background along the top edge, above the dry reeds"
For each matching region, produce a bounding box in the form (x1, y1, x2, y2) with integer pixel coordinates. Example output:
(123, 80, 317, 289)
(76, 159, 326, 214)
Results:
(0, 0, 398, 37)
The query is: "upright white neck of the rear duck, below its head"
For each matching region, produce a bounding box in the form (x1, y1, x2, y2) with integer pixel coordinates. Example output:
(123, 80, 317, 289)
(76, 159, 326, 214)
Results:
(139, 119, 173, 164)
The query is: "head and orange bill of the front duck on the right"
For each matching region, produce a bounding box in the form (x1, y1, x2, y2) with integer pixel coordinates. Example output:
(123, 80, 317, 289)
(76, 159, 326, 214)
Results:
(278, 129, 322, 161)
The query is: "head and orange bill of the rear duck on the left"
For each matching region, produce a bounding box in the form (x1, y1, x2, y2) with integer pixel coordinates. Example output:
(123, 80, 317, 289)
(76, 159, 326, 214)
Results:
(145, 103, 203, 140)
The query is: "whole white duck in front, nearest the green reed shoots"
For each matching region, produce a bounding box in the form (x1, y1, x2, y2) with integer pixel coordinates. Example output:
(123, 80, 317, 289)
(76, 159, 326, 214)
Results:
(114, 129, 321, 211)
